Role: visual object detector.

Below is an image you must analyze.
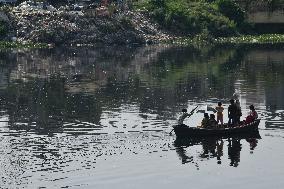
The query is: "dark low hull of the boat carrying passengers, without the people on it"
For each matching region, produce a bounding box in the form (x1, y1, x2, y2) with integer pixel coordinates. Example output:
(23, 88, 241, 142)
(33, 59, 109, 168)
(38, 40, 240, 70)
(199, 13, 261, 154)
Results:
(173, 119, 260, 137)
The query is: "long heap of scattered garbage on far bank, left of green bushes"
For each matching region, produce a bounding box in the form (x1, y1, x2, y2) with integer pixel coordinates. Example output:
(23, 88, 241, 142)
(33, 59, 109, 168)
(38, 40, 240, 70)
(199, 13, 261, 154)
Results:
(6, 1, 174, 44)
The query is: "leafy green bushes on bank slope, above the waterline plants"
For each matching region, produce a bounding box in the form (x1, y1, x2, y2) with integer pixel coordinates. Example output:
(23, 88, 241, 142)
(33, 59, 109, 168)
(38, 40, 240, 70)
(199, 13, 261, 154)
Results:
(136, 0, 245, 37)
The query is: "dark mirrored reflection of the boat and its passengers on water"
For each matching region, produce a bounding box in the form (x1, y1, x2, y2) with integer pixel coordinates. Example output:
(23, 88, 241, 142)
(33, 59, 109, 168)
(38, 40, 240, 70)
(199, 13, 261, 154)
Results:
(174, 132, 261, 169)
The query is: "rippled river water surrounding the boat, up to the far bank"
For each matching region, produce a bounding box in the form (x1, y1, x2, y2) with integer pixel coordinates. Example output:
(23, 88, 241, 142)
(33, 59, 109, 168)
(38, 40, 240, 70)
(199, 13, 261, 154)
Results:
(0, 45, 284, 189)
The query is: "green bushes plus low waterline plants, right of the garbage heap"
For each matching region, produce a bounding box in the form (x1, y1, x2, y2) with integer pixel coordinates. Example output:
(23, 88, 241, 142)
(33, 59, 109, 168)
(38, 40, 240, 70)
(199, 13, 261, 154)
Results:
(136, 0, 284, 45)
